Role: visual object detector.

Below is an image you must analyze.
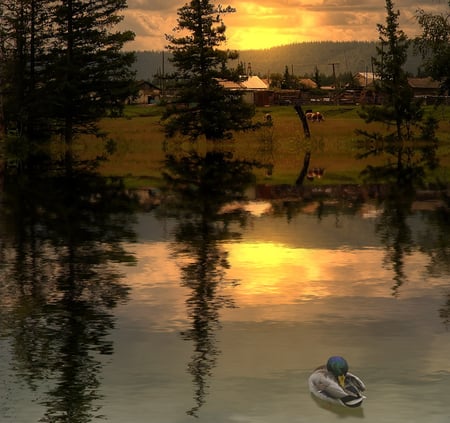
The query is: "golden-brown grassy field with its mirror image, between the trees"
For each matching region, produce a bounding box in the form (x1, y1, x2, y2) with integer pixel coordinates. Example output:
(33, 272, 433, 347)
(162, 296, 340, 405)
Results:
(79, 106, 450, 187)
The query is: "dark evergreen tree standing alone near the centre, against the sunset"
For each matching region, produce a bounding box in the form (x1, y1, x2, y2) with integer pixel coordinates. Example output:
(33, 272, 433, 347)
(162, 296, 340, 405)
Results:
(164, 0, 254, 141)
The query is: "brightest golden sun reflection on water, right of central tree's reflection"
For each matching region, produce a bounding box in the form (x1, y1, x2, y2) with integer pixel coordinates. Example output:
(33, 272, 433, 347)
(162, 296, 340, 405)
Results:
(228, 242, 400, 305)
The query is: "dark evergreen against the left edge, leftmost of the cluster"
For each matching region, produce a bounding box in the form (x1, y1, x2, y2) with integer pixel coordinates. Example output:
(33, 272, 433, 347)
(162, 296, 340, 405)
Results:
(0, 0, 49, 144)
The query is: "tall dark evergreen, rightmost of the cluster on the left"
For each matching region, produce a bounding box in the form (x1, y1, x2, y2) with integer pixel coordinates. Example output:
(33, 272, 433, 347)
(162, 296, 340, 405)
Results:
(46, 0, 134, 167)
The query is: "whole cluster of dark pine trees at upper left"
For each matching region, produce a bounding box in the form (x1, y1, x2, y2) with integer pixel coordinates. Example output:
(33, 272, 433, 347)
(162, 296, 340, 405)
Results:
(0, 0, 134, 172)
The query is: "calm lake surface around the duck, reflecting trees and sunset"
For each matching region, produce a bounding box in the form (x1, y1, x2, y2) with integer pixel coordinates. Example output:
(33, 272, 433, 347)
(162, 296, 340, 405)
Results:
(0, 173, 450, 423)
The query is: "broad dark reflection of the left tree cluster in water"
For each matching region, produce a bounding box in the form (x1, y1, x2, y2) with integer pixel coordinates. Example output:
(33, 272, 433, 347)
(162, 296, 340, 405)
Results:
(0, 174, 135, 423)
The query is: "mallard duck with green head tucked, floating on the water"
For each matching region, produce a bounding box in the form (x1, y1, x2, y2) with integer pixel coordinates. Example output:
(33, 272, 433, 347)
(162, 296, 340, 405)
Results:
(308, 356, 366, 408)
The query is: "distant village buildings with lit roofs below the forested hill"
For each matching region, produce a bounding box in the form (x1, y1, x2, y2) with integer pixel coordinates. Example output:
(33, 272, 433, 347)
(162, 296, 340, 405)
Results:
(129, 66, 450, 107)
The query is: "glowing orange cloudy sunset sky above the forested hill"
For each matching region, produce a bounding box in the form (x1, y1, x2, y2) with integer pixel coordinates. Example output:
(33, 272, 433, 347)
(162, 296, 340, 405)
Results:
(120, 0, 449, 51)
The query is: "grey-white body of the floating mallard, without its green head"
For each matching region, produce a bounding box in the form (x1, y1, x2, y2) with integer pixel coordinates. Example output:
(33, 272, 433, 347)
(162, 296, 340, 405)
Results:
(308, 366, 366, 407)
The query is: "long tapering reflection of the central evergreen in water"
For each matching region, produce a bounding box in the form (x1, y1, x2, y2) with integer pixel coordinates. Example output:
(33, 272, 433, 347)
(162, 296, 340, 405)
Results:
(164, 150, 256, 416)
